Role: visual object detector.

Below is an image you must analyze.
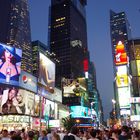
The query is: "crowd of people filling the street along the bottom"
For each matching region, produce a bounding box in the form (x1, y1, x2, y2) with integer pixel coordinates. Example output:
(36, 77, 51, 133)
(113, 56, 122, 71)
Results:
(0, 126, 140, 140)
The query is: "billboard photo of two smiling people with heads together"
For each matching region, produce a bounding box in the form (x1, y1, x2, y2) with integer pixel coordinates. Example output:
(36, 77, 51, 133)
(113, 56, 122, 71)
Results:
(0, 87, 34, 115)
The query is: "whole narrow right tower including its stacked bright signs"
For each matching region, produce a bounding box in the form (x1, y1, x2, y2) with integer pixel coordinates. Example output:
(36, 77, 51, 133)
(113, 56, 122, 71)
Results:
(110, 11, 131, 117)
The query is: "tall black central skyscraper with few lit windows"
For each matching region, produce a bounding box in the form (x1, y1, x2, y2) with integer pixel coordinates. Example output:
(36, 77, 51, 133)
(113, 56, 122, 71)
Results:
(49, 0, 87, 86)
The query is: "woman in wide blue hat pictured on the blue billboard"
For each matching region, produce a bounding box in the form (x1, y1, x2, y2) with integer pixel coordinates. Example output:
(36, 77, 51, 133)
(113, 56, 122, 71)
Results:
(0, 45, 21, 82)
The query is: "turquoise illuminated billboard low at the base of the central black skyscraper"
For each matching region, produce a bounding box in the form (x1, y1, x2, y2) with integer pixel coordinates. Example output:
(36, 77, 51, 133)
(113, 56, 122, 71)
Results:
(70, 106, 91, 118)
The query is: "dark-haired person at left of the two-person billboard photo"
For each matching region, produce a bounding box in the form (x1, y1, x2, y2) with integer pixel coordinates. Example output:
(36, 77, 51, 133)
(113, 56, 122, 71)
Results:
(2, 88, 18, 114)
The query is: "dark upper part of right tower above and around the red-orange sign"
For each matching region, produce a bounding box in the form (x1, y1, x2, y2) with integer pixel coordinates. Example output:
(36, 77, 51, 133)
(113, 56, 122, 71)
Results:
(110, 10, 131, 70)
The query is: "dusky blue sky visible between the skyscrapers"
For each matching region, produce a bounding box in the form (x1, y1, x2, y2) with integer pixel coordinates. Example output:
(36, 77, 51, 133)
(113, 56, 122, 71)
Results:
(29, 0, 140, 118)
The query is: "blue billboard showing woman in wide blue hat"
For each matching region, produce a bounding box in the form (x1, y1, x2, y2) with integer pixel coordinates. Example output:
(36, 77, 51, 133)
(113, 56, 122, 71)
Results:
(0, 43, 22, 85)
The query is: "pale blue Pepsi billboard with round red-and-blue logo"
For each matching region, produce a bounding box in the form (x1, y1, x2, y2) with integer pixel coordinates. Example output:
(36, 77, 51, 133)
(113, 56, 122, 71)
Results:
(19, 71, 37, 93)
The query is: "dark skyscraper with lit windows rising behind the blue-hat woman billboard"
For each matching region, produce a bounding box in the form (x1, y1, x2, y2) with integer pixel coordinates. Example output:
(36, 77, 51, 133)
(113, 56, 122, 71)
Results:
(0, 0, 32, 72)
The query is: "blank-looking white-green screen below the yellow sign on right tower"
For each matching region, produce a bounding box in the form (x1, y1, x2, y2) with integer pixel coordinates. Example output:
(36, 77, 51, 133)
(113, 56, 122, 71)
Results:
(118, 87, 130, 108)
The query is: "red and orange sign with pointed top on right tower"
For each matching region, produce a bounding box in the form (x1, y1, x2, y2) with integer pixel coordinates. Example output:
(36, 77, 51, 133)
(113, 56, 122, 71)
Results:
(115, 41, 128, 65)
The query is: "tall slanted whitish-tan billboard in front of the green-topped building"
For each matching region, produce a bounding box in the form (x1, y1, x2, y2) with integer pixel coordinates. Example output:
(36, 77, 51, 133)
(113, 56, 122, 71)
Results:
(38, 53, 55, 92)
